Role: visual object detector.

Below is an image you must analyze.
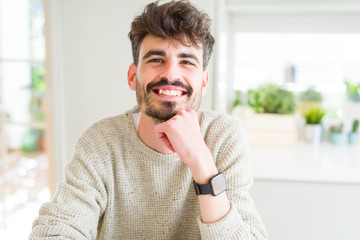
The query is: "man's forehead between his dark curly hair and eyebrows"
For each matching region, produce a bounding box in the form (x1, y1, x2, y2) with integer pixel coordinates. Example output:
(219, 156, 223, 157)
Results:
(139, 35, 203, 59)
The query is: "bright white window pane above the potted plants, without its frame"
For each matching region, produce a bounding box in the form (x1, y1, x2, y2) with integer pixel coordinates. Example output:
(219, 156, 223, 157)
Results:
(234, 33, 360, 93)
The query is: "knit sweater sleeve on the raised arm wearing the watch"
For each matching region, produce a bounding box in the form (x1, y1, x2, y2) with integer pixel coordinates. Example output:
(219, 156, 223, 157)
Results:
(198, 116, 267, 240)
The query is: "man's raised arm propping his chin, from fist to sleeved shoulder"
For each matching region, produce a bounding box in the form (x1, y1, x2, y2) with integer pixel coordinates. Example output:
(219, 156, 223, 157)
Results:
(156, 110, 266, 240)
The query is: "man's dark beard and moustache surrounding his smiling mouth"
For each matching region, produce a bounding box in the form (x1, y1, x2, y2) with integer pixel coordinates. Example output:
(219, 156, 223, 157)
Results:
(136, 79, 202, 124)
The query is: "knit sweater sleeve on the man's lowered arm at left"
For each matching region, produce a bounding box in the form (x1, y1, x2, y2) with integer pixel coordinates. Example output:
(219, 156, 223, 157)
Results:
(29, 135, 107, 240)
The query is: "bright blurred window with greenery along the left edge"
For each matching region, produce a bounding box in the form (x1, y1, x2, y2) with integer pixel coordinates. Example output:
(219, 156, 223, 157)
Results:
(0, 0, 50, 239)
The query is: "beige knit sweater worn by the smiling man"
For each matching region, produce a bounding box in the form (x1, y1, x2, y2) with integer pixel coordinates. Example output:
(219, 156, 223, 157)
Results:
(30, 110, 266, 240)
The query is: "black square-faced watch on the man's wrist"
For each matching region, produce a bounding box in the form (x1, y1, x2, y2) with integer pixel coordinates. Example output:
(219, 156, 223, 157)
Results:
(194, 173, 226, 196)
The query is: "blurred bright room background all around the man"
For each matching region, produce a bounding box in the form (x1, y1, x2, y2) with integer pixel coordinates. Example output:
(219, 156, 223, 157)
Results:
(0, 0, 360, 240)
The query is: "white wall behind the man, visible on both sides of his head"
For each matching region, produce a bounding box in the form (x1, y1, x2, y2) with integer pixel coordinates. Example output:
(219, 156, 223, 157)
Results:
(50, 0, 215, 182)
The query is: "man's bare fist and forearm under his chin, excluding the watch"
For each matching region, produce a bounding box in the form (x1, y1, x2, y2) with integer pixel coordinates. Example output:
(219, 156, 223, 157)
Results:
(155, 110, 230, 223)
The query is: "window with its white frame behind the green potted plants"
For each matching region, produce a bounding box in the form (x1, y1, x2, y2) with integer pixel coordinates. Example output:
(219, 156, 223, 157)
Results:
(216, 0, 360, 118)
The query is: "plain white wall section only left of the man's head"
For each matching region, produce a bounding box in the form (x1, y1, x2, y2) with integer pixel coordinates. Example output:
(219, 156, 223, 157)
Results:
(62, 0, 146, 171)
